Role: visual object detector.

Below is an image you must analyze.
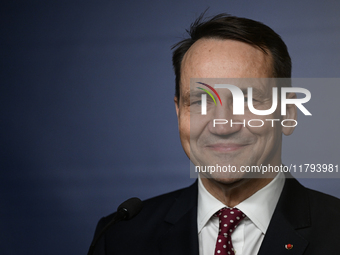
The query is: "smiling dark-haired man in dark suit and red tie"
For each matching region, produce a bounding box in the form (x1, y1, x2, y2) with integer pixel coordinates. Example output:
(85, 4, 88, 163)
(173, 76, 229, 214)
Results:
(89, 14, 340, 255)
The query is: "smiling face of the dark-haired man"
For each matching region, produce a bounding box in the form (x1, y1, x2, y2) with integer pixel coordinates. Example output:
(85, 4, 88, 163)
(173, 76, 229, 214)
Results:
(175, 39, 292, 183)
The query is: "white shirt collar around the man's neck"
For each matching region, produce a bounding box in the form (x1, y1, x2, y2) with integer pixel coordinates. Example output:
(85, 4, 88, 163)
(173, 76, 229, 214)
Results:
(197, 173, 285, 234)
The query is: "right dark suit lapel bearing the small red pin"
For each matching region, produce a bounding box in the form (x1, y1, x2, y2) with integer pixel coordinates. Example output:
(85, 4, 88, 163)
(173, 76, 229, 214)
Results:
(258, 178, 310, 255)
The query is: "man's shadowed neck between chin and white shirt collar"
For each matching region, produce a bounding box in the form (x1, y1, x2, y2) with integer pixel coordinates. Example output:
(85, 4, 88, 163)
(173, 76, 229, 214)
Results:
(201, 174, 276, 207)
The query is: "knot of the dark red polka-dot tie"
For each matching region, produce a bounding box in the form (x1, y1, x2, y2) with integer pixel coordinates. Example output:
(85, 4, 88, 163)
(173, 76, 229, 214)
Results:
(215, 208, 245, 236)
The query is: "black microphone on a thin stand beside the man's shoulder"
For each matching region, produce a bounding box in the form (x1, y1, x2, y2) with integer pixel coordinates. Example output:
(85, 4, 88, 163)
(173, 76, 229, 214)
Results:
(87, 197, 143, 255)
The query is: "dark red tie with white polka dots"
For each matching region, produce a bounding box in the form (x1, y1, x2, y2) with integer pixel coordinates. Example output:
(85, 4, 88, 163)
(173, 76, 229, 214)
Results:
(214, 208, 245, 255)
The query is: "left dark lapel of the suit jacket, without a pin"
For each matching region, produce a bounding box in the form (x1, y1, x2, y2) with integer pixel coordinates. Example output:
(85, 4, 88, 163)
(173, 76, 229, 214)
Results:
(159, 181, 198, 255)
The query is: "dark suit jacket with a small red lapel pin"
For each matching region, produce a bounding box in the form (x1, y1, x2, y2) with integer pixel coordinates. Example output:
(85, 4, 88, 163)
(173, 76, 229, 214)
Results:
(89, 179, 340, 255)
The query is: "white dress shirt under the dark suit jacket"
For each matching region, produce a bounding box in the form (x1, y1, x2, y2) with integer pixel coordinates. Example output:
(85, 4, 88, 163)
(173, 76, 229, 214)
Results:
(197, 173, 285, 255)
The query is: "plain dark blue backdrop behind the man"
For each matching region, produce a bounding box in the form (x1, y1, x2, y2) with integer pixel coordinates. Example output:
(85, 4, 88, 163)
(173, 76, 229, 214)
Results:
(0, 0, 340, 255)
